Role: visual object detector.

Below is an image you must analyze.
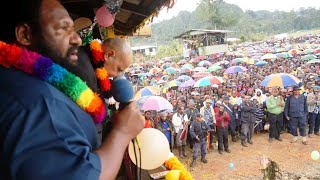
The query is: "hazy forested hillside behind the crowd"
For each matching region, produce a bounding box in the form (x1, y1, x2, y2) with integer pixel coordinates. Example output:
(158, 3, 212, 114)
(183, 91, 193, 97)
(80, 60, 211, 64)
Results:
(132, 0, 320, 46)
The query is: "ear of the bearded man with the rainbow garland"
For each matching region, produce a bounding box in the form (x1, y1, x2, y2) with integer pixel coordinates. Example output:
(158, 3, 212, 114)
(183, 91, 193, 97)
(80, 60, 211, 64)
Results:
(15, 23, 32, 46)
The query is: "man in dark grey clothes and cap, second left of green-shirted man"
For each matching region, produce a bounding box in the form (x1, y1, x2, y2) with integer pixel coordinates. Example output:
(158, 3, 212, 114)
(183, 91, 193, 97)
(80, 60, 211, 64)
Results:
(240, 95, 256, 147)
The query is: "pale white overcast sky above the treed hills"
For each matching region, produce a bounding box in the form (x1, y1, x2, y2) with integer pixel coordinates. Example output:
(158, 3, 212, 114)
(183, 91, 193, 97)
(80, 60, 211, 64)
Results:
(154, 0, 320, 22)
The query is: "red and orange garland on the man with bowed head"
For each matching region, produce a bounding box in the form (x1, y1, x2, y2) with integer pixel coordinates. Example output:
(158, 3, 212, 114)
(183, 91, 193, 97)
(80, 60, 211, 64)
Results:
(90, 39, 111, 91)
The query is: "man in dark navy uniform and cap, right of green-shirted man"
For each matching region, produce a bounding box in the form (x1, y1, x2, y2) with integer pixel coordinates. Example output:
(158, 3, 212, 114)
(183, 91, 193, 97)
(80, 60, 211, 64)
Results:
(284, 86, 308, 145)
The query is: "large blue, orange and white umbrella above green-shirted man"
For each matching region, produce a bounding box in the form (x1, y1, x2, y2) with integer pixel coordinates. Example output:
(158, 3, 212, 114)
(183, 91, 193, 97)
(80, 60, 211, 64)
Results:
(260, 73, 300, 88)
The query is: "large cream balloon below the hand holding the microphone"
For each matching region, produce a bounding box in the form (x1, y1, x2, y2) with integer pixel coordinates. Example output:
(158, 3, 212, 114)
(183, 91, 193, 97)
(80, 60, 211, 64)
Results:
(128, 128, 170, 170)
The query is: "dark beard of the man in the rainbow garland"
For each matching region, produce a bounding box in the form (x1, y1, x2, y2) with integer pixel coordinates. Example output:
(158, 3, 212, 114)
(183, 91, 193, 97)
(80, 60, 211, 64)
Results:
(34, 35, 78, 69)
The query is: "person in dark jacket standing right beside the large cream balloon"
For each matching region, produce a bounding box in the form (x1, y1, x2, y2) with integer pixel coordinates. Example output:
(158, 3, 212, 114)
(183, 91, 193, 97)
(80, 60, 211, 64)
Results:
(156, 112, 174, 151)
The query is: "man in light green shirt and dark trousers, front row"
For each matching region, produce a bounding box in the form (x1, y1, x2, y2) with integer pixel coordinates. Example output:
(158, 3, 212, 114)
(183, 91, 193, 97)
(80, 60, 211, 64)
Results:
(266, 87, 285, 143)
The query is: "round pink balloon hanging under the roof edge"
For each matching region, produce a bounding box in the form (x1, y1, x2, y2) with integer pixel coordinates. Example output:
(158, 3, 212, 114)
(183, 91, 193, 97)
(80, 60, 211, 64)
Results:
(96, 5, 115, 27)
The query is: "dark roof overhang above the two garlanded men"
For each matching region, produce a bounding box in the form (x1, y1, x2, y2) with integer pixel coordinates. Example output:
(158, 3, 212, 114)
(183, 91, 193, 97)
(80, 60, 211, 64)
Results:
(61, 0, 172, 36)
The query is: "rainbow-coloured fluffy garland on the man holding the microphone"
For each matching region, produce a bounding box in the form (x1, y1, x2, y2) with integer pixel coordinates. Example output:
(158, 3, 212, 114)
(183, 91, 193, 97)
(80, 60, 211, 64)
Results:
(0, 41, 106, 123)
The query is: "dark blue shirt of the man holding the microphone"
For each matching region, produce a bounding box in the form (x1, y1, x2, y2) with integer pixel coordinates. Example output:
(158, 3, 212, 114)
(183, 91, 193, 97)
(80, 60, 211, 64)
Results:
(0, 66, 101, 180)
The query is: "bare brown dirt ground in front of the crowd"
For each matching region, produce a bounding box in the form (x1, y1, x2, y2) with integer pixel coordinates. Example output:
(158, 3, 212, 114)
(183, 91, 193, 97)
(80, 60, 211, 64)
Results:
(174, 133, 320, 180)
